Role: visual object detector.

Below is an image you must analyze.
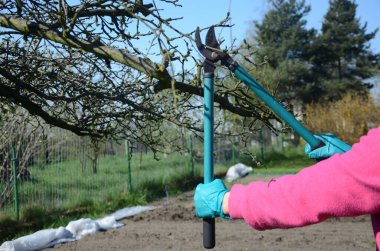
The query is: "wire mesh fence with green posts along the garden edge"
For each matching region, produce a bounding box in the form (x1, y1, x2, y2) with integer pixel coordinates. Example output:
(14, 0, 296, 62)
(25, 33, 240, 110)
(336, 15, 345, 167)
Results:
(0, 118, 294, 221)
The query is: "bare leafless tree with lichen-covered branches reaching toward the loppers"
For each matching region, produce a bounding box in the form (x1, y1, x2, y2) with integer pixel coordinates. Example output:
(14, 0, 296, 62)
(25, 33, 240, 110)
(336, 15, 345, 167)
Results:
(0, 0, 280, 152)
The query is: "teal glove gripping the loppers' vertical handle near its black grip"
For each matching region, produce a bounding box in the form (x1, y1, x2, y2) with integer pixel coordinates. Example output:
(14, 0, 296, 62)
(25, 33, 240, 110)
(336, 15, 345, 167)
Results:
(194, 179, 231, 219)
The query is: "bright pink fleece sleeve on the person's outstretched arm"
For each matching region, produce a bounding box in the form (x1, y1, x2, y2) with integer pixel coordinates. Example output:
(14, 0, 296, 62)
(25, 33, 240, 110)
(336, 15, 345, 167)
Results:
(229, 127, 380, 230)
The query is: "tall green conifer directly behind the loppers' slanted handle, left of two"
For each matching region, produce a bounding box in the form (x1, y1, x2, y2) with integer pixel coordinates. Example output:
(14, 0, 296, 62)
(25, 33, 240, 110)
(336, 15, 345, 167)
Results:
(249, 0, 316, 104)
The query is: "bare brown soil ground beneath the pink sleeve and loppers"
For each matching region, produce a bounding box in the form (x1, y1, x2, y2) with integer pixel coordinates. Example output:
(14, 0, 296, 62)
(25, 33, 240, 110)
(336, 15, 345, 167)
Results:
(46, 176, 375, 251)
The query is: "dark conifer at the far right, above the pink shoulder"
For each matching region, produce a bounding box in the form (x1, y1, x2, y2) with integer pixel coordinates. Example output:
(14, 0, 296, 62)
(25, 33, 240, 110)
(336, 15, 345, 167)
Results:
(312, 0, 379, 100)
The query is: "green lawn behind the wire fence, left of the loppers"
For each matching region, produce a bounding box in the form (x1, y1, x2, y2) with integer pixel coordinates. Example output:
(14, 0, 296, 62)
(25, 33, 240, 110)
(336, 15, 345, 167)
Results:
(15, 153, 193, 208)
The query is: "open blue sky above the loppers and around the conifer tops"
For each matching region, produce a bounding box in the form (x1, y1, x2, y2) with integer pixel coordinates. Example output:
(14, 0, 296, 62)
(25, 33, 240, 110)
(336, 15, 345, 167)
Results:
(157, 0, 380, 53)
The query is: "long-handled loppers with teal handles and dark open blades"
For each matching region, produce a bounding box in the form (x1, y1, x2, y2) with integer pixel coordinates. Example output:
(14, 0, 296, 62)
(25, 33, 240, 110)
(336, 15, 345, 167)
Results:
(195, 27, 324, 248)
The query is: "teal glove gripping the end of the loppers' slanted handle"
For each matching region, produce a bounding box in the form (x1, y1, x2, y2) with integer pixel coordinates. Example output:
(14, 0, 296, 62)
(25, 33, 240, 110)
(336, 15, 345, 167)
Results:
(305, 133, 351, 159)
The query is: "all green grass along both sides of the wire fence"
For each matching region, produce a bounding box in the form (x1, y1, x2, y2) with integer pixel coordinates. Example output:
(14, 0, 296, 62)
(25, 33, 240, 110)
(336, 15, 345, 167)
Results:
(0, 146, 314, 243)
